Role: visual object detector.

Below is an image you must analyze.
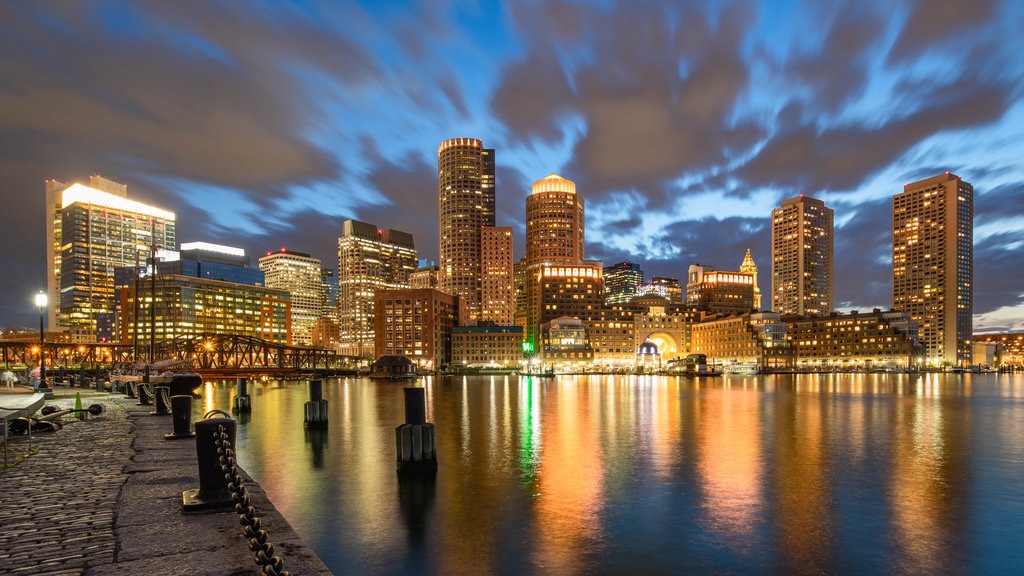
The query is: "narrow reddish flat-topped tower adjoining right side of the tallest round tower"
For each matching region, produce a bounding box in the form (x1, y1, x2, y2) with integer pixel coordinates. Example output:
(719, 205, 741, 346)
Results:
(480, 227, 515, 326)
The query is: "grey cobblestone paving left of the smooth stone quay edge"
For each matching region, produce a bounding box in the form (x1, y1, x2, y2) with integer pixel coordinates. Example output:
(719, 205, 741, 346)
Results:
(0, 390, 134, 574)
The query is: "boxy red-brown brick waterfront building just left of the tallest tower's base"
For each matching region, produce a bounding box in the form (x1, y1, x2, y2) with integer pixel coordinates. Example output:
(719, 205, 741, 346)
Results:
(373, 288, 468, 370)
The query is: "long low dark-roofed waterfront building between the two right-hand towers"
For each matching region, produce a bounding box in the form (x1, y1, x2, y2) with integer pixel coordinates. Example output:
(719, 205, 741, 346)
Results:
(782, 308, 924, 371)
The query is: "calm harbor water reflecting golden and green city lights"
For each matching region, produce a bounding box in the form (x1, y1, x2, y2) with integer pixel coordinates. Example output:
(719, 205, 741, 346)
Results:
(196, 374, 1024, 575)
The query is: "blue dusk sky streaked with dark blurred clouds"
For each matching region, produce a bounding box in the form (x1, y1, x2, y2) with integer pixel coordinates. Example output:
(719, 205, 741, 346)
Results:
(0, 0, 1024, 332)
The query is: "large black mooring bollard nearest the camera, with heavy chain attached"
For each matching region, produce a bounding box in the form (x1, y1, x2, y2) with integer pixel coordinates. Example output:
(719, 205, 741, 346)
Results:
(182, 409, 238, 512)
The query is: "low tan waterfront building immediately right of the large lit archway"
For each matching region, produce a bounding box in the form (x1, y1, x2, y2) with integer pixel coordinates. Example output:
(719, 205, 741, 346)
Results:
(691, 312, 794, 369)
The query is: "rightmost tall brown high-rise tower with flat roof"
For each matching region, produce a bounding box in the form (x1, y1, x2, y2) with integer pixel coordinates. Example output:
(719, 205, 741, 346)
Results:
(893, 172, 974, 366)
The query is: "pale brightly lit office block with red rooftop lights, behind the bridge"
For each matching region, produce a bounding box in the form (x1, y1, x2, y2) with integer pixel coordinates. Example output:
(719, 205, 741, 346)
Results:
(259, 248, 328, 346)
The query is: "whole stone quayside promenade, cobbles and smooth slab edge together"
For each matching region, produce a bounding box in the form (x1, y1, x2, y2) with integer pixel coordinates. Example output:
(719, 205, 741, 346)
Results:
(0, 387, 331, 576)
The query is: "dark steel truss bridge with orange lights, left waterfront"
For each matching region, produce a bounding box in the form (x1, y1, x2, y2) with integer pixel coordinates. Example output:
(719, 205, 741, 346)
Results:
(0, 334, 367, 376)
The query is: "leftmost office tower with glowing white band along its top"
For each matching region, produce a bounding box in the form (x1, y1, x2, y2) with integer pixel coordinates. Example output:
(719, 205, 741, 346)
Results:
(46, 176, 175, 341)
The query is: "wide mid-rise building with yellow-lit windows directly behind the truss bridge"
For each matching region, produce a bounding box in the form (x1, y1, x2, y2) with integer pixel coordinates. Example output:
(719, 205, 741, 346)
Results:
(126, 274, 291, 348)
